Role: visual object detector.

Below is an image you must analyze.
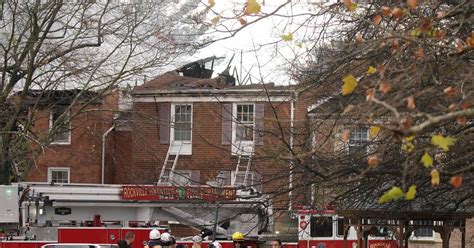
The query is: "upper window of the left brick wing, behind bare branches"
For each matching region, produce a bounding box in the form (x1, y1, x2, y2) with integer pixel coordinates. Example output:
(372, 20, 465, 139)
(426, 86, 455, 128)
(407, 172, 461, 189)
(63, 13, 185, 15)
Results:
(49, 107, 71, 145)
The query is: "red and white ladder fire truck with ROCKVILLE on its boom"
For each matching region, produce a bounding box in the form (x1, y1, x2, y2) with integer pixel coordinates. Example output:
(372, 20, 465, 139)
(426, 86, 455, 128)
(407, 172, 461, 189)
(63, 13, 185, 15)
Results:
(0, 183, 271, 248)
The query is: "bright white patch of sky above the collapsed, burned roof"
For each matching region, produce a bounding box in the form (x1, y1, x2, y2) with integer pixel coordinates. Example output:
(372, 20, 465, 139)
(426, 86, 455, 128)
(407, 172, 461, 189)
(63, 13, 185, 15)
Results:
(189, 0, 314, 84)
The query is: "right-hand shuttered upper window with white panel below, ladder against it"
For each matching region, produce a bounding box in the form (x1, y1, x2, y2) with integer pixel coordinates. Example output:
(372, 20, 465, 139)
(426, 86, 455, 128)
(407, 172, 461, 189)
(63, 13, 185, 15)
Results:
(232, 103, 255, 153)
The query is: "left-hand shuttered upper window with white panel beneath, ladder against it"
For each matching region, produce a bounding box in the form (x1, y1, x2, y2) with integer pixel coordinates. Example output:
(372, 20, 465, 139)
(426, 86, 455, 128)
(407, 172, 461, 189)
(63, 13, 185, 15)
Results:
(170, 103, 193, 155)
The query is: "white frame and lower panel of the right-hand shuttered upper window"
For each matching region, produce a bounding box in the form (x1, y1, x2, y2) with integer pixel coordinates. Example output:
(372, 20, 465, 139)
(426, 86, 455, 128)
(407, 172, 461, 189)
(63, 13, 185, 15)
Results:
(232, 102, 255, 155)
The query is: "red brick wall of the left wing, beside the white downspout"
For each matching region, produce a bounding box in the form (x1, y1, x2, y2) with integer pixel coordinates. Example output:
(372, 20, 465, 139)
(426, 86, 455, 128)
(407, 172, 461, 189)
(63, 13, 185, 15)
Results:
(27, 93, 118, 183)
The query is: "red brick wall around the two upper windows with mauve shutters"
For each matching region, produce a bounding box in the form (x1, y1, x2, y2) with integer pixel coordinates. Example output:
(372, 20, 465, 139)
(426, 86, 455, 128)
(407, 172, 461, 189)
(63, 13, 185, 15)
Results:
(122, 102, 298, 208)
